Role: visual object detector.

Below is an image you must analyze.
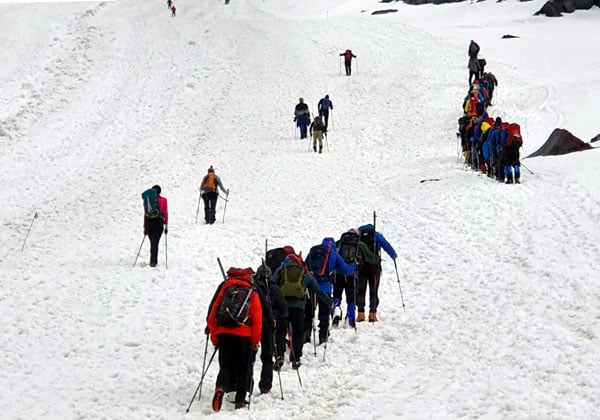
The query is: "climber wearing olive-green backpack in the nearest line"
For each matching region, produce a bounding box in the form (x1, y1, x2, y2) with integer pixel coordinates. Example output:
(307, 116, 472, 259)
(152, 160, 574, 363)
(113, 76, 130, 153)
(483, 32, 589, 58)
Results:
(273, 254, 331, 370)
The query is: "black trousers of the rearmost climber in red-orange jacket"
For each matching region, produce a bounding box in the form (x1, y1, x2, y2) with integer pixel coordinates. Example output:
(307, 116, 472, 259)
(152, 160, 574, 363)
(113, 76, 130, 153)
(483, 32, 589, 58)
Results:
(217, 334, 253, 403)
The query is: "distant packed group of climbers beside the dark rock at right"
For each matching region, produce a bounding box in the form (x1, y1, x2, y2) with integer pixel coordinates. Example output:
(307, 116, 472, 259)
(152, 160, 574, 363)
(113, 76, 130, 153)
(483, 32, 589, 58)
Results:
(458, 40, 523, 184)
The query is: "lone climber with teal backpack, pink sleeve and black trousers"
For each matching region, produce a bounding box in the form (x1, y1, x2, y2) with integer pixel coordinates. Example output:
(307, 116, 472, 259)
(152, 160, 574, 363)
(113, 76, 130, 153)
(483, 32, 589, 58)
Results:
(142, 185, 169, 267)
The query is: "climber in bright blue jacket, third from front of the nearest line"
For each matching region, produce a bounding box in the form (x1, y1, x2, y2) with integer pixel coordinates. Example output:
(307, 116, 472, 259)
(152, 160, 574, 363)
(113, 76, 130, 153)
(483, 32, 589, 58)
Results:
(304, 238, 356, 345)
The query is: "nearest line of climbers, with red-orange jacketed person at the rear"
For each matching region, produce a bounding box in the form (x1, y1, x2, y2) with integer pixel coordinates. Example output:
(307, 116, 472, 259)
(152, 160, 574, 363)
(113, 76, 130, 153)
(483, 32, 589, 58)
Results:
(205, 224, 397, 411)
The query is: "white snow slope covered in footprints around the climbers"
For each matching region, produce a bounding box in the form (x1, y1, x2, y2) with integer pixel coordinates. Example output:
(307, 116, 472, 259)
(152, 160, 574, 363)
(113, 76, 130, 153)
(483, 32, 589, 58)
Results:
(0, 0, 600, 419)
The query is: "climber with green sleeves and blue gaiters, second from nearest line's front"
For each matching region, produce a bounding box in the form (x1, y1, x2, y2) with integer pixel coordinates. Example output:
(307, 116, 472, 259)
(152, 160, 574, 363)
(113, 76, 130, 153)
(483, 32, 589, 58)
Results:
(332, 229, 377, 328)
